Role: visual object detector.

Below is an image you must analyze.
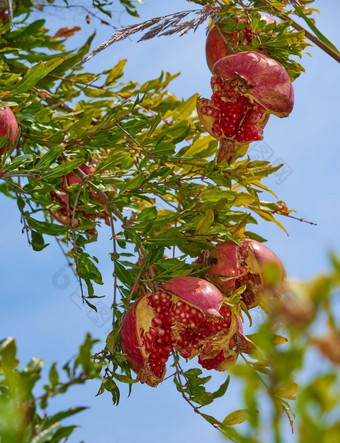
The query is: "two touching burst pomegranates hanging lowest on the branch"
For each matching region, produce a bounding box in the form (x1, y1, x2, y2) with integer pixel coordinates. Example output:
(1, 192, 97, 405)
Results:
(121, 239, 285, 386)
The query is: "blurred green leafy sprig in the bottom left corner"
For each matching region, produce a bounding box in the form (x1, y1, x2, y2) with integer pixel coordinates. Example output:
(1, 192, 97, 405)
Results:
(0, 334, 101, 443)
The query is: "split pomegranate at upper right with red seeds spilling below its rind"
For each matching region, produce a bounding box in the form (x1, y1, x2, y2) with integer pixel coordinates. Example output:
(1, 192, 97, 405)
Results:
(197, 51, 294, 162)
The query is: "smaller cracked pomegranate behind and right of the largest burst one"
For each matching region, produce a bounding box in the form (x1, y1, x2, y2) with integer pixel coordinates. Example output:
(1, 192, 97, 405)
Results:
(205, 239, 286, 309)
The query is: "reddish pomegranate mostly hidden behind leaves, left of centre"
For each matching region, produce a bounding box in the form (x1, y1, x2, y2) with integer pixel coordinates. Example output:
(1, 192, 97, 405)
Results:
(50, 159, 108, 227)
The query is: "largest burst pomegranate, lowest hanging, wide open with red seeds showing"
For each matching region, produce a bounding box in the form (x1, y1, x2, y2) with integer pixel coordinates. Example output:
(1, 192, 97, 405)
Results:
(121, 277, 250, 386)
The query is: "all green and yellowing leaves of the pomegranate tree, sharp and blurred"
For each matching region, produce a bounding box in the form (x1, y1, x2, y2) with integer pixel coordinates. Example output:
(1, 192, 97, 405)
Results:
(0, 0, 340, 442)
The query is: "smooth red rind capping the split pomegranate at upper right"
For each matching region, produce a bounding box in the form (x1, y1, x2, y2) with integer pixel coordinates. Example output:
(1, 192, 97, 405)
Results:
(213, 51, 294, 117)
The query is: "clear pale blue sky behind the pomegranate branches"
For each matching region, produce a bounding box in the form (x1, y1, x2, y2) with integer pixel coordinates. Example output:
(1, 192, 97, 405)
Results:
(0, 0, 340, 443)
